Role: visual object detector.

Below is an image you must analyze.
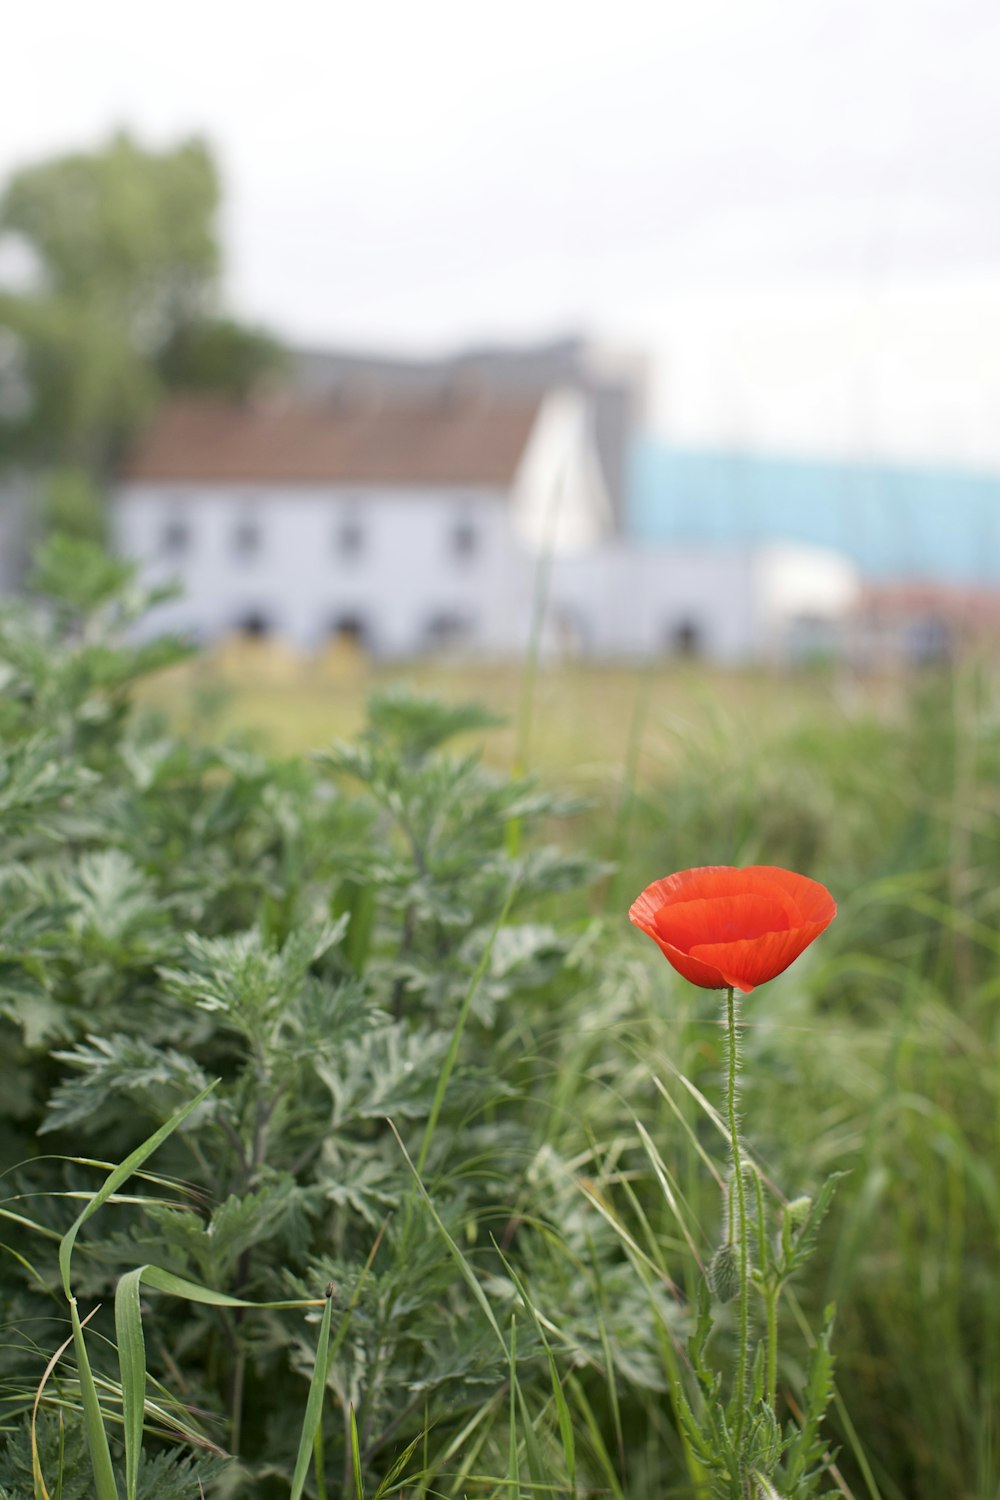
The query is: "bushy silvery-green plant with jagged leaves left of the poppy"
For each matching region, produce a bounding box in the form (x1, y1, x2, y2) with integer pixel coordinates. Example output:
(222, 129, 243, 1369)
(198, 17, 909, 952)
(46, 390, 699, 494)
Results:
(0, 543, 620, 1500)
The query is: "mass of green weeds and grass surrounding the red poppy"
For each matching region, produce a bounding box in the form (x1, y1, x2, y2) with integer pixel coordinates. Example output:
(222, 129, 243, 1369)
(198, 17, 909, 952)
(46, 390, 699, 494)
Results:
(0, 543, 1000, 1500)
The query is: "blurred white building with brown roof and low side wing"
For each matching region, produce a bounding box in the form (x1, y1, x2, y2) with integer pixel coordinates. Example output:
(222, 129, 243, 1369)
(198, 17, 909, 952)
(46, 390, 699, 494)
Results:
(114, 384, 855, 662)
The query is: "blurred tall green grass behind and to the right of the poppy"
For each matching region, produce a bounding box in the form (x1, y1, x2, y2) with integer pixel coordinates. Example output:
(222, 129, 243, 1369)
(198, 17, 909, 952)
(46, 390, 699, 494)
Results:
(599, 663, 1000, 1500)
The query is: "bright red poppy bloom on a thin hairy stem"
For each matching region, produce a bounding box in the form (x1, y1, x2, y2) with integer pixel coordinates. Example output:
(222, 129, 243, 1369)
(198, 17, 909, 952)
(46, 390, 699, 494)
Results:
(628, 864, 837, 995)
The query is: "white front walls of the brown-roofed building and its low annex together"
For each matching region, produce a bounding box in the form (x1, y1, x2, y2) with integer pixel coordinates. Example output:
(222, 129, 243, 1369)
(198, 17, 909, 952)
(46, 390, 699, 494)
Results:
(115, 485, 853, 662)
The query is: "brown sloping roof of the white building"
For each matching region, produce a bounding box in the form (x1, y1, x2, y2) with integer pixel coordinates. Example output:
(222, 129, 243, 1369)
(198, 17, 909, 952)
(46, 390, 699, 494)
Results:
(124, 392, 548, 486)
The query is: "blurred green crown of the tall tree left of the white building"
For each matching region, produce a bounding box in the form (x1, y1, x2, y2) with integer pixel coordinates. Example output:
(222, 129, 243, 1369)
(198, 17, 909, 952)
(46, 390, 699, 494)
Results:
(0, 134, 279, 480)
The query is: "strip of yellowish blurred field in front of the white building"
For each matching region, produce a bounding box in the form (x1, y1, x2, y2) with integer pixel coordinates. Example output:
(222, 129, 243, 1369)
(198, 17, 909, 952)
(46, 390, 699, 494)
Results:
(142, 641, 903, 785)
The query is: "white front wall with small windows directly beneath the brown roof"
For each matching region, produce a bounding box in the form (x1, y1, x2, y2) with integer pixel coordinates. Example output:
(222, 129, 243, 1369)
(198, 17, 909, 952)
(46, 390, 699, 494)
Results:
(115, 485, 529, 656)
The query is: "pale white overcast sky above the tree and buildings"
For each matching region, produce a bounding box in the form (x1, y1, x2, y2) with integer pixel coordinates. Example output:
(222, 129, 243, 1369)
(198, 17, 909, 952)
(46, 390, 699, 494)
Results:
(0, 0, 1000, 467)
